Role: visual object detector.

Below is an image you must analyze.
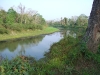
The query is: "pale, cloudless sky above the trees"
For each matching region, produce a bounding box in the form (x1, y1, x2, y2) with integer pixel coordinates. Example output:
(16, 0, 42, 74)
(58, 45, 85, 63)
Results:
(0, 0, 93, 20)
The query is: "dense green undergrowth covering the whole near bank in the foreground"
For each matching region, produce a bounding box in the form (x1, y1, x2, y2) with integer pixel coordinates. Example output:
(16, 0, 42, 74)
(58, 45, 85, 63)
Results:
(0, 27, 100, 75)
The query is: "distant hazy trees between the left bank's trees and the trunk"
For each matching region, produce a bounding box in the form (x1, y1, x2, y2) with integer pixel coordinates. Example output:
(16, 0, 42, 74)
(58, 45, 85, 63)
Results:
(48, 14, 88, 27)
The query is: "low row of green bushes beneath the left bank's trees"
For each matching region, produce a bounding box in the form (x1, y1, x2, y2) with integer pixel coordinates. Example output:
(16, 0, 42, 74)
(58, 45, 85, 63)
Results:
(3, 23, 43, 31)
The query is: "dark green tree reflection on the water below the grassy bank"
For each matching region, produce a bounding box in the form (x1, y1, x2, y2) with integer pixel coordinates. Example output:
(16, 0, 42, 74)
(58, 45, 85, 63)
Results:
(0, 35, 44, 52)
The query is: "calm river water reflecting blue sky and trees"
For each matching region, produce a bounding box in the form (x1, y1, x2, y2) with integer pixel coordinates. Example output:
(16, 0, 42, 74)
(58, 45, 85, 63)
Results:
(0, 31, 75, 60)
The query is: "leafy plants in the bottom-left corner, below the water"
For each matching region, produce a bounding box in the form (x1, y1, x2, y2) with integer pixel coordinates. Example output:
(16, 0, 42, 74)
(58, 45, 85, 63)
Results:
(0, 56, 35, 75)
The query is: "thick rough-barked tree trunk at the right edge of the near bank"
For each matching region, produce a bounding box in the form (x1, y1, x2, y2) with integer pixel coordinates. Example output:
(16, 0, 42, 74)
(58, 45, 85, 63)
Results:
(84, 0, 100, 53)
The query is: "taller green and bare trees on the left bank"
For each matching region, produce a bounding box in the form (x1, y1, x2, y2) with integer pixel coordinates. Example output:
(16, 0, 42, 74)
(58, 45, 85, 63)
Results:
(0, 4, 46, 34)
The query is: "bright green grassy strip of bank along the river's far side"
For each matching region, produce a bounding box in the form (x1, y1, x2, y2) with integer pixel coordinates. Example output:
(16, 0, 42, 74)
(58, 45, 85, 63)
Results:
(0, 27, 59, 41)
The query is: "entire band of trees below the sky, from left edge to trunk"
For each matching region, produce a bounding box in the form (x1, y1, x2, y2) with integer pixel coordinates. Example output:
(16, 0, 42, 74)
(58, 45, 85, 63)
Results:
(0, 3, 88, 34)
